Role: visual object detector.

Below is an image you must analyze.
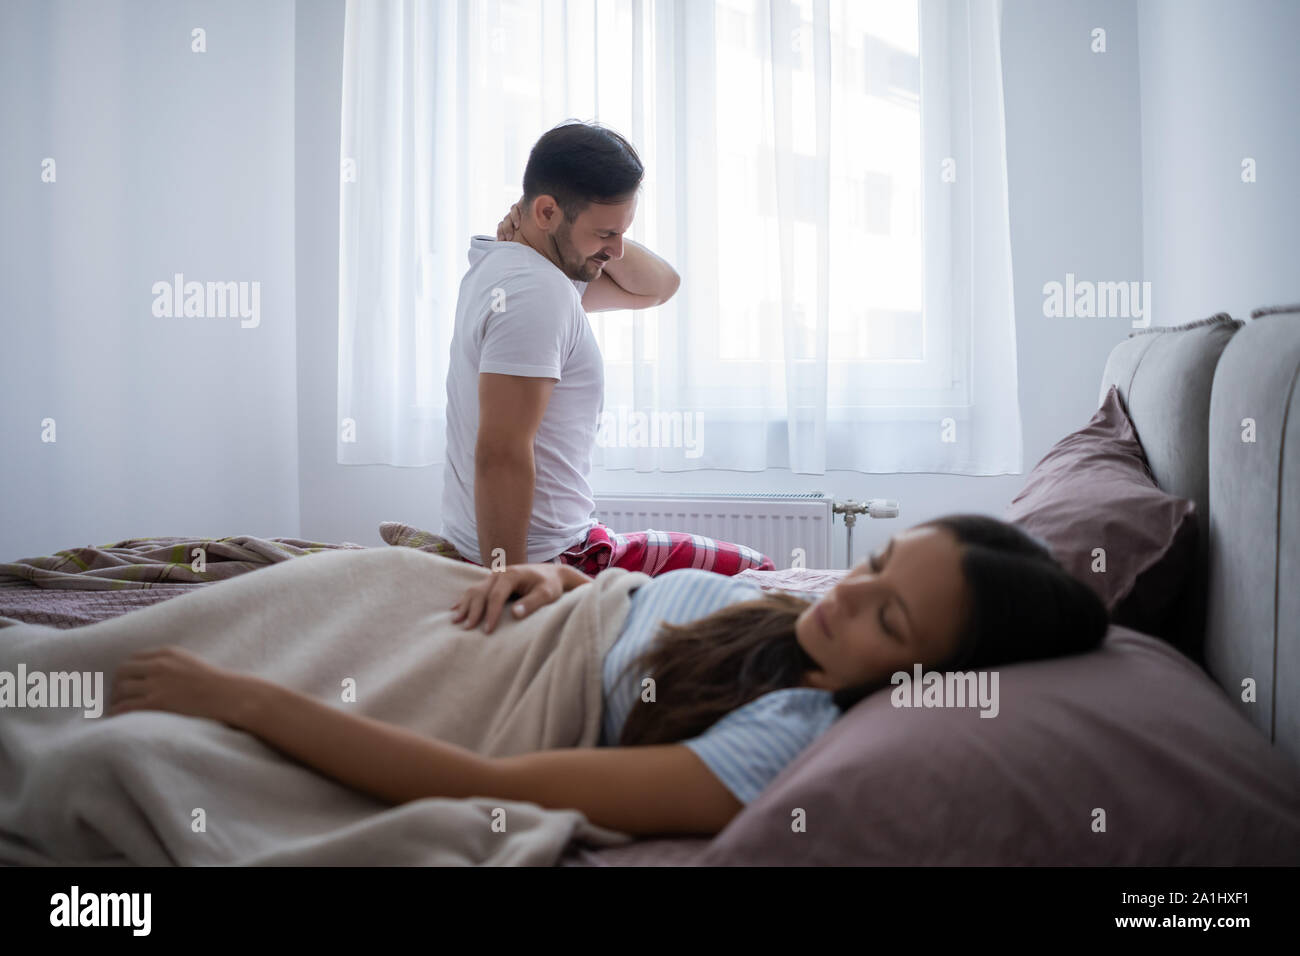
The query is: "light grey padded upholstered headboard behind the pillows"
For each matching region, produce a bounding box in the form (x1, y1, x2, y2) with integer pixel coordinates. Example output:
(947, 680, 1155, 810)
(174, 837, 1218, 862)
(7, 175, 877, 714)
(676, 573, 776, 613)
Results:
(1100, 306, 1300, 762)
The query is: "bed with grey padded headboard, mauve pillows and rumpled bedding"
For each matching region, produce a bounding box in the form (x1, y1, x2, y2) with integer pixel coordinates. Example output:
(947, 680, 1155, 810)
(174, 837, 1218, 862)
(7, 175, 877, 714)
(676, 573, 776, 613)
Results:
(0, 307, 1300, 866)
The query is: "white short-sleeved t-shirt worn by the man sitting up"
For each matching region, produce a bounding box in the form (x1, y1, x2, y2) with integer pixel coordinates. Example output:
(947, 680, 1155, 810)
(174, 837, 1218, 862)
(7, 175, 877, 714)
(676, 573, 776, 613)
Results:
(442, 235, 605, 562)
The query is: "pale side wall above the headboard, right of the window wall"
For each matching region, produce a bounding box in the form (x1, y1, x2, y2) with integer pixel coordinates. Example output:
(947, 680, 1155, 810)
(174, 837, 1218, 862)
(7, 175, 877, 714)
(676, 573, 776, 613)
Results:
(1138, 0, 1300, 325)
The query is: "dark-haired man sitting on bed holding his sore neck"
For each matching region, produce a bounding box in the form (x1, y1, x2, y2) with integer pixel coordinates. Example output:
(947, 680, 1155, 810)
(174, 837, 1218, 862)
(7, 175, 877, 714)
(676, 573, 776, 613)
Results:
(442, 122, 774, 574)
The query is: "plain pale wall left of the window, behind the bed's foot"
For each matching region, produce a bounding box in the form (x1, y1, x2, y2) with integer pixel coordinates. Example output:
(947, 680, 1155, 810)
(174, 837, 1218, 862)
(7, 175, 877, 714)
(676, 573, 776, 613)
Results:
(0, 0, 299, 561)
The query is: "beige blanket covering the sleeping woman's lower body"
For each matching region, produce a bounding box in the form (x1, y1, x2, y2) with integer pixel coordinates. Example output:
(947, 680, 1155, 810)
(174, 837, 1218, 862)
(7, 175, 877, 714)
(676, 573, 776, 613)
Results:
(0, 548, 649, 865)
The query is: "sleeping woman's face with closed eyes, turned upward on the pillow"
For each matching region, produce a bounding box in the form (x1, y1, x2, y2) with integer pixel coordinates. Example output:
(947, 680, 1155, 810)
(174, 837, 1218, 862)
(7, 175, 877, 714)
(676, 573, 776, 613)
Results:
(794, 527, 966, 691)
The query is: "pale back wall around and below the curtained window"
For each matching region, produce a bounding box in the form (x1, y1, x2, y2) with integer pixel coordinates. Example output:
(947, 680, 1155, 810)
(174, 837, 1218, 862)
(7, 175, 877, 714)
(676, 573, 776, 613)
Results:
(296, 0, 1141, 566)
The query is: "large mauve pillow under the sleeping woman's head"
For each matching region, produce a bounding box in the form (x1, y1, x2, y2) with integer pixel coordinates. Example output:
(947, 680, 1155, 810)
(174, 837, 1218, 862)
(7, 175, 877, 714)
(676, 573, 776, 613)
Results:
(693, 626, 1300, 866)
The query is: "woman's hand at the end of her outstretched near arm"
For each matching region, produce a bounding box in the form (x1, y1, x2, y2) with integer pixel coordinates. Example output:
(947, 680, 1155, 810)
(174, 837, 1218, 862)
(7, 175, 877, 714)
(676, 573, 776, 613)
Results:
(108, 648, 244, 723)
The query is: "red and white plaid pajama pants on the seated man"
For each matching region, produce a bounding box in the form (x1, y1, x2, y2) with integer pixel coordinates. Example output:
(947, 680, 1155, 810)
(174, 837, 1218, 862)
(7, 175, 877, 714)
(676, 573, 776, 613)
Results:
(441, 522, 776, 578)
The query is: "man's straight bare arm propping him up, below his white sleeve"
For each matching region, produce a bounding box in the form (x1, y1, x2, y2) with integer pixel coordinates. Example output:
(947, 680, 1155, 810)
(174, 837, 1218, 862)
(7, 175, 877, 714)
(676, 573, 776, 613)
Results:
(475, 372, 555, 567)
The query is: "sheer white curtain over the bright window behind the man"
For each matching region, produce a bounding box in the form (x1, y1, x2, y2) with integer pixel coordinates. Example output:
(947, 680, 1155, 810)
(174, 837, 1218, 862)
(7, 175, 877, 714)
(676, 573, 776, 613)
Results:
(338, 0, 1022, 475)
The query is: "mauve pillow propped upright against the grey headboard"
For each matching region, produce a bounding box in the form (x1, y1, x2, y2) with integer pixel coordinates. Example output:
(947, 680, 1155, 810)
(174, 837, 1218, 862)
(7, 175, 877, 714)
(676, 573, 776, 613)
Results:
(1002, 385, 1199, 652)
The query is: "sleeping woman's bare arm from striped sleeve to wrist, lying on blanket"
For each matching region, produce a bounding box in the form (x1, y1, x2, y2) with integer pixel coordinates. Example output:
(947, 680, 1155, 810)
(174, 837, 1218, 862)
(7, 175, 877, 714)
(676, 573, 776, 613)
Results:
(228, 676, 744, 835)
